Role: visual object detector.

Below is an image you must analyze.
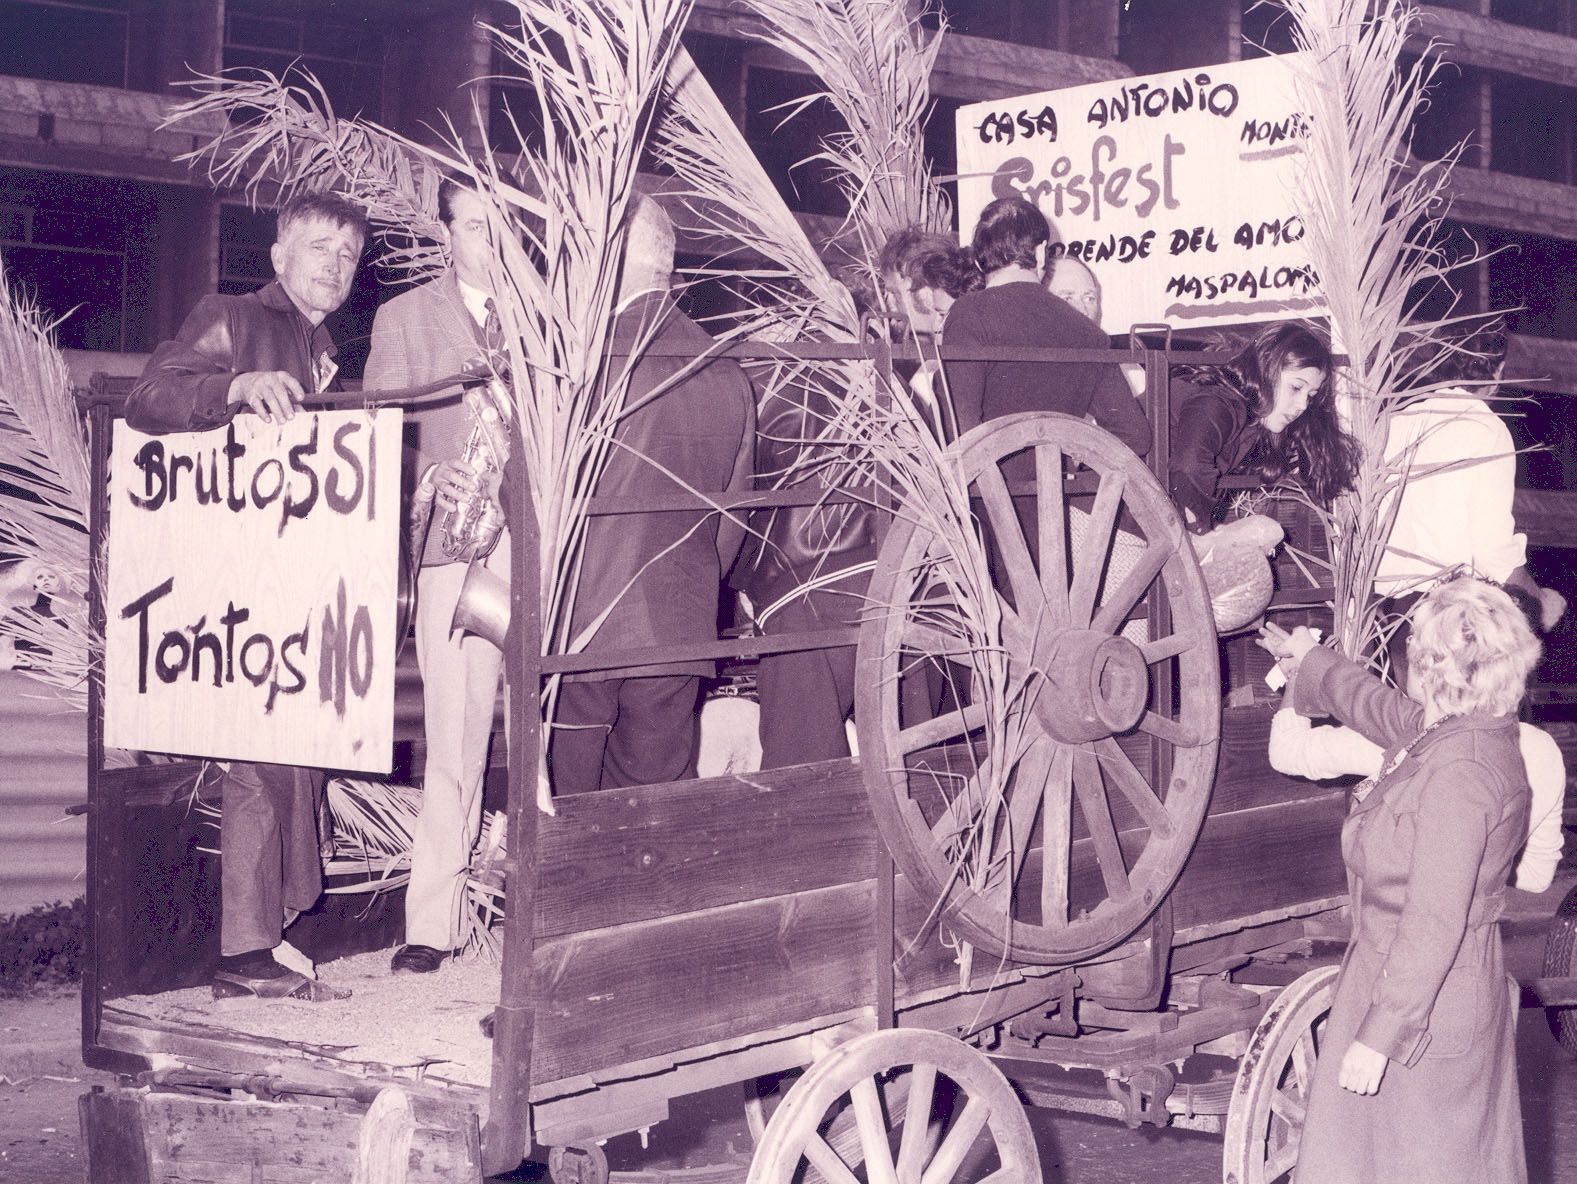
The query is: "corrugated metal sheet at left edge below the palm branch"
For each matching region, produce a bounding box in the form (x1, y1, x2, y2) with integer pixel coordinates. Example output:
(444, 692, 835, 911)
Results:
(0, 670, 88, 916)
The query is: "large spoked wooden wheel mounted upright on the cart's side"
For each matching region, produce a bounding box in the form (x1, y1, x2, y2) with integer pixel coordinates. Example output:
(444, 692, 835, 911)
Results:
(856, 413, 1221, 965)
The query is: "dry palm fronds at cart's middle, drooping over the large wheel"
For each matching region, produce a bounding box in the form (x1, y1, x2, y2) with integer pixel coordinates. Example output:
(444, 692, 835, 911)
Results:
(656, 0, 1028, 974)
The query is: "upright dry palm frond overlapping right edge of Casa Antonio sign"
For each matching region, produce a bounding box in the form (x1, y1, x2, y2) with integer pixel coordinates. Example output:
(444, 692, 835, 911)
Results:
(1285, 0, 1482, 668)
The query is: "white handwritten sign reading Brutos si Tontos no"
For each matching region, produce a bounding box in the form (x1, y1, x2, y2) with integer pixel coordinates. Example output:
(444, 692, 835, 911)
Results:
(104, 410, 401, 773)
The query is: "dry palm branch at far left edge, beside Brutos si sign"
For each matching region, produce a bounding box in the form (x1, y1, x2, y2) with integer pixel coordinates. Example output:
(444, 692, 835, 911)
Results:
(0, 270, 93, 709)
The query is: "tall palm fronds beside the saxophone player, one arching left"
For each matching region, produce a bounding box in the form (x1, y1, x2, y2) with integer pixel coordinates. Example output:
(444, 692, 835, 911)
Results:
(156, 0, 689, 945)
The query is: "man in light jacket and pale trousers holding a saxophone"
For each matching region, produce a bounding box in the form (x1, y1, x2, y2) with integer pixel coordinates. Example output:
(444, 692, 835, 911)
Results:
(363, 180, 509, 974)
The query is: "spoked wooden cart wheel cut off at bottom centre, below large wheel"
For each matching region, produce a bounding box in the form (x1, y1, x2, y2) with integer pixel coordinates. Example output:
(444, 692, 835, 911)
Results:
(746, 1029, 1042, 1184)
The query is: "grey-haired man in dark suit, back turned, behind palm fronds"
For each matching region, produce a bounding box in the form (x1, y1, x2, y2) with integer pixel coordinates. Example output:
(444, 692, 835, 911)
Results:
(549, 197, 755, 795)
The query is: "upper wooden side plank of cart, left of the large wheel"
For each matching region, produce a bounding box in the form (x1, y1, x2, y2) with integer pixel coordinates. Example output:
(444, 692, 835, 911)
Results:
(536, 761, 877, 938)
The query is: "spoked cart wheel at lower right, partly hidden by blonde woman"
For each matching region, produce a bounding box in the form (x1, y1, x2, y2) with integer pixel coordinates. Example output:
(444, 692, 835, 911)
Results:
(1222, 966, 1340, 1184)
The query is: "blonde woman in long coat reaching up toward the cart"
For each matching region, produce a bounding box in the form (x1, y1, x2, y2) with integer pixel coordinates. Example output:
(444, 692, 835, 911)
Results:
(1262, 577, 1539, 1184)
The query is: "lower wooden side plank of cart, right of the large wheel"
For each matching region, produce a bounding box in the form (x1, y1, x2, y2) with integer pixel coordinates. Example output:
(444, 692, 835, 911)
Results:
(1172, 790, 1347, 930)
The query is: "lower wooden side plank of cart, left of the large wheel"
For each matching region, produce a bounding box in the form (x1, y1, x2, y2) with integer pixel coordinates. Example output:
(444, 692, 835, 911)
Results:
(531, 882, 875, 1082)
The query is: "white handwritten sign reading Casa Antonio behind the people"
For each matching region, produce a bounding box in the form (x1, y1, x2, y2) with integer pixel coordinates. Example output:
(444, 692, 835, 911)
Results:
(956, 55, 1325, 333)
